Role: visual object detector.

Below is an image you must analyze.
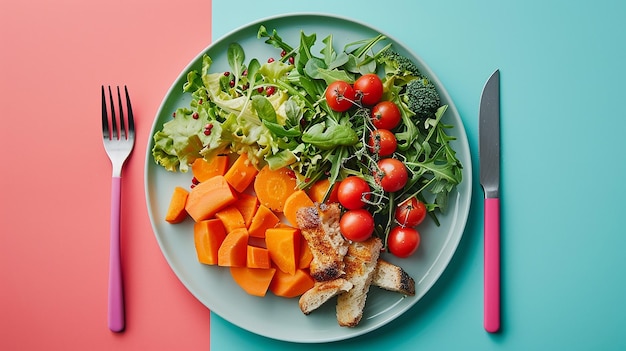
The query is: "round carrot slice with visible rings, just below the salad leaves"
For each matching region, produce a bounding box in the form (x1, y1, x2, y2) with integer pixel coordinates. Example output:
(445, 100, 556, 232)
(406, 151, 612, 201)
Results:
(254, 166, 297, 212)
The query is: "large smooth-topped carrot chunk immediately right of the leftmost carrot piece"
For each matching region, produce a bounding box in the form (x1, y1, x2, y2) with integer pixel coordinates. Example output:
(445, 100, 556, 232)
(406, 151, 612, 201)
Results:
(185, 176, 237, 222)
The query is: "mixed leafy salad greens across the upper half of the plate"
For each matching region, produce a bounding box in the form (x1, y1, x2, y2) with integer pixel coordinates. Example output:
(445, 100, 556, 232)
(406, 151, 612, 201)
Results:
(152, 26, 462, 239)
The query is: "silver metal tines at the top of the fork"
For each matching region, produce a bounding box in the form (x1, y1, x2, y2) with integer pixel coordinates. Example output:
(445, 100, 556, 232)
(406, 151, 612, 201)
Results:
(102, 85, 135, 140)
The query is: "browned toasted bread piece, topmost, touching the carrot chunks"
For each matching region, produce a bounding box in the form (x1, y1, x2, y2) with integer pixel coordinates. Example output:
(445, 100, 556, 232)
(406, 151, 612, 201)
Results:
(296, 203, 348, 282)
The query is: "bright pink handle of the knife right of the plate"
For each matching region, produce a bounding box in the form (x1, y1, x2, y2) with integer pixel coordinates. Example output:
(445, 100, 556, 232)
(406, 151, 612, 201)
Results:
(484, 198, 500, 333)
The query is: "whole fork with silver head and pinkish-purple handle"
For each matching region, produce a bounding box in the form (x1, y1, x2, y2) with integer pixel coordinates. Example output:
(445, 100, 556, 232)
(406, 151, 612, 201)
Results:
(102, 85, 135, 332)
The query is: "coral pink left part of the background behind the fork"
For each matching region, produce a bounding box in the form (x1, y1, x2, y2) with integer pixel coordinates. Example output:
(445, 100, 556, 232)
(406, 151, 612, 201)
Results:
(0, 0, 211, 350)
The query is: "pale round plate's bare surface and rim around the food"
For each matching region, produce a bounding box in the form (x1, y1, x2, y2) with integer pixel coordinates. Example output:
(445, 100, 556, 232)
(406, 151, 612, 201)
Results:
(145, 14, 472, 343)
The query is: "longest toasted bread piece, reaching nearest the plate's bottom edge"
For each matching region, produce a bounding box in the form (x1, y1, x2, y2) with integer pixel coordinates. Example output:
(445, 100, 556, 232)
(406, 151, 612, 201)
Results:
(337, 237, 383, 327)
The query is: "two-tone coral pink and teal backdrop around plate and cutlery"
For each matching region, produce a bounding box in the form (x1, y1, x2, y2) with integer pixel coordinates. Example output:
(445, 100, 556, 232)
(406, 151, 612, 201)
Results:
(0, 0, 626, 351)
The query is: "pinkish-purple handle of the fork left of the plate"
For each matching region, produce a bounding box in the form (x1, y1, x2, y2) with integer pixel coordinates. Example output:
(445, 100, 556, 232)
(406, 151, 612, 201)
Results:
(109, 177, 124, 332)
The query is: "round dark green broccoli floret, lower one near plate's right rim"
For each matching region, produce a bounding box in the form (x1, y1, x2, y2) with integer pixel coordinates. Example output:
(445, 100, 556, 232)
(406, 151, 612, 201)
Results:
(402, 77, 441, 117)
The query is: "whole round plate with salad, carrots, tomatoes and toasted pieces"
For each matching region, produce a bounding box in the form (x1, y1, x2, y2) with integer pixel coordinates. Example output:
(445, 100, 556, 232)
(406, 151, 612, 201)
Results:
(146, 14, 471, 342)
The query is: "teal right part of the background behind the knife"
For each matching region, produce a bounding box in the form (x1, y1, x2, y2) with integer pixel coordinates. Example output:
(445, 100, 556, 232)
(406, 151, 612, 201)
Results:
(210, 0, 626, 351)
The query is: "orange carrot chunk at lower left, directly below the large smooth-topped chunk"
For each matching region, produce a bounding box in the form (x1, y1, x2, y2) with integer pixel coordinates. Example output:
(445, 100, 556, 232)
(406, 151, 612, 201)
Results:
(193, 219, 226, 265)
